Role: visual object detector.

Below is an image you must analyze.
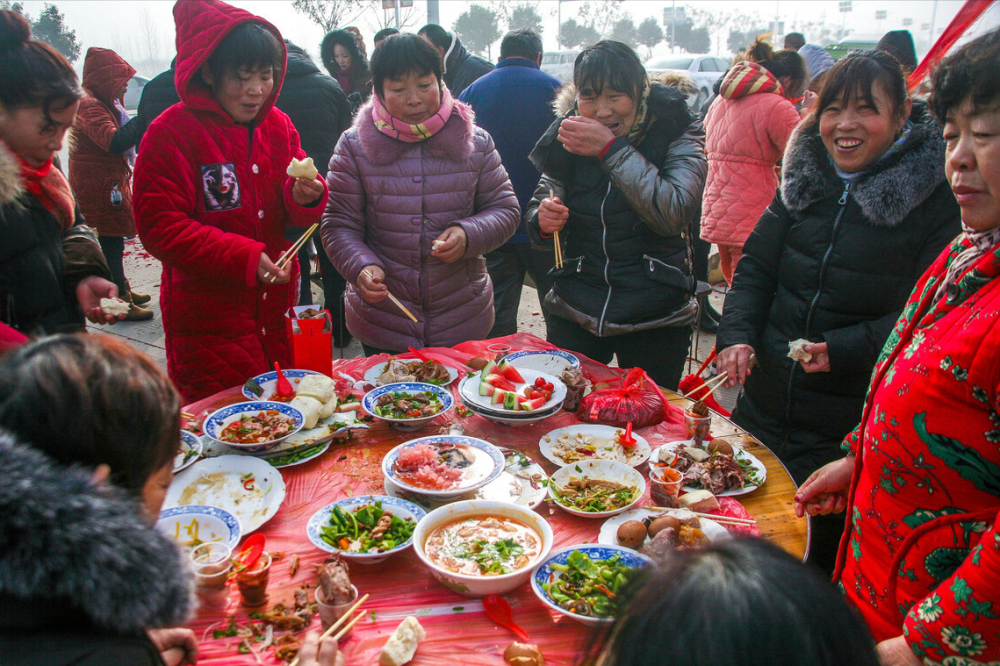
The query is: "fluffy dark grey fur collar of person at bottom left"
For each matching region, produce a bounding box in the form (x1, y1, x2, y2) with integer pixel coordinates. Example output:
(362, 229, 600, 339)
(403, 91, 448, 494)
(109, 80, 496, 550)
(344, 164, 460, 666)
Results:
(0, 433, 193, 634)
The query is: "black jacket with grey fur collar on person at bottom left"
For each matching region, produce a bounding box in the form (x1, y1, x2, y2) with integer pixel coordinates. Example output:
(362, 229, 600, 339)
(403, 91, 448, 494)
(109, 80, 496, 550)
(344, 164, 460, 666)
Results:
(0, 432, 193, 666)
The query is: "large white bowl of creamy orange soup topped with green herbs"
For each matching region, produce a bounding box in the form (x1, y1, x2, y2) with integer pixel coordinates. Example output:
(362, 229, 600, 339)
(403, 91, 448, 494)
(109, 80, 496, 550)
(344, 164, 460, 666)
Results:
(413, 500, 553, 597)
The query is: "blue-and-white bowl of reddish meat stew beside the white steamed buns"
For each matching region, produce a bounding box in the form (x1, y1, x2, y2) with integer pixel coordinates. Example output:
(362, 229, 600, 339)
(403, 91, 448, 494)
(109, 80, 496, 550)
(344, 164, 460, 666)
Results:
(204, 400, 305, 453)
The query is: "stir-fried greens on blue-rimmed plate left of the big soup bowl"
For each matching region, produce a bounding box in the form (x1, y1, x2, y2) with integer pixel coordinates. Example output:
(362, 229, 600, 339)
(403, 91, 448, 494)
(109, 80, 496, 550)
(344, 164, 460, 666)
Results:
(319, 500, 417, 553)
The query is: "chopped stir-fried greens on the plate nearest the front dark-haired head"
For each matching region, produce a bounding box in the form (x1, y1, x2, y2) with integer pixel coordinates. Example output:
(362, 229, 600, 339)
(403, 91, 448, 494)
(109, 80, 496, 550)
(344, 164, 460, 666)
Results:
(542, 550, 635, 617)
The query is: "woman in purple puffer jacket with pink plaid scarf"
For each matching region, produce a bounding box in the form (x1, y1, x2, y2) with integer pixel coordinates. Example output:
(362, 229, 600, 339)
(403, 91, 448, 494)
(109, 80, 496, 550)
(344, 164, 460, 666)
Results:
(322, 35, 521, 356)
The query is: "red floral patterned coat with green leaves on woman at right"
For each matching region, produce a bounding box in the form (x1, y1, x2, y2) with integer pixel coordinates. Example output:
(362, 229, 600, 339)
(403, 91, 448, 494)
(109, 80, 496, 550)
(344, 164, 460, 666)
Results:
(834, 236, 1000, 666)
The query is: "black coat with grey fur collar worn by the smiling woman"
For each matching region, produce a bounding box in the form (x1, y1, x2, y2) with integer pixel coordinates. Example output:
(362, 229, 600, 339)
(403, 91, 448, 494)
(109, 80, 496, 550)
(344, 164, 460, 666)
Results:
(716, 102, 961, 482)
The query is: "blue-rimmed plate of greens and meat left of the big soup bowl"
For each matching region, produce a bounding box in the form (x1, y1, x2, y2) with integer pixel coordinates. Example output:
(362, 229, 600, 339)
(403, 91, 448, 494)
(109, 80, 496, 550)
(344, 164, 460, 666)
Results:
(306, 495, 427, 564)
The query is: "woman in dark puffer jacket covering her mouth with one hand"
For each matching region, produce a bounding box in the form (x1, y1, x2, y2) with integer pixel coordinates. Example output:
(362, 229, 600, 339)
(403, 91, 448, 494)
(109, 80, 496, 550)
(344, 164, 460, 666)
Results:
(525, 41, 708, 388)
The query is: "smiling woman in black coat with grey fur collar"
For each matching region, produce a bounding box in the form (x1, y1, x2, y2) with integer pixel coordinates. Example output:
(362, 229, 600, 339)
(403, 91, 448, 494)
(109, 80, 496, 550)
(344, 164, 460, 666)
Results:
(716, 51, 960, 570)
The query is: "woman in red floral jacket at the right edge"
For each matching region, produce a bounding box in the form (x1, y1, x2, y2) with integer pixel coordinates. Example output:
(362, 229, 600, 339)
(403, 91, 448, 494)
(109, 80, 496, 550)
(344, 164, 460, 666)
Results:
(796, 31, 1000, 666)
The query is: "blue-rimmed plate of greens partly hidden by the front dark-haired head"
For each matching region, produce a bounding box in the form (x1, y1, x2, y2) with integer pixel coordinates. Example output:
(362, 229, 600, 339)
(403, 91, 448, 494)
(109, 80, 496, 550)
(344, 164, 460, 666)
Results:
(531, 544, 653, 626)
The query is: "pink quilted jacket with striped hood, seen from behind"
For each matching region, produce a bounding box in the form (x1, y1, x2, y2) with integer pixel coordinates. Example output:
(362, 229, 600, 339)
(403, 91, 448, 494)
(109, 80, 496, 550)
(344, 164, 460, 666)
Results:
(701, 62, 800, 247)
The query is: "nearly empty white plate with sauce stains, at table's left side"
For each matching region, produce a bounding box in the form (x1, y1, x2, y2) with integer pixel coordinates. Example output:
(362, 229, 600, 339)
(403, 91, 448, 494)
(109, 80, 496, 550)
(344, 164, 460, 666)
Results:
(163, 456, 285, 534)
